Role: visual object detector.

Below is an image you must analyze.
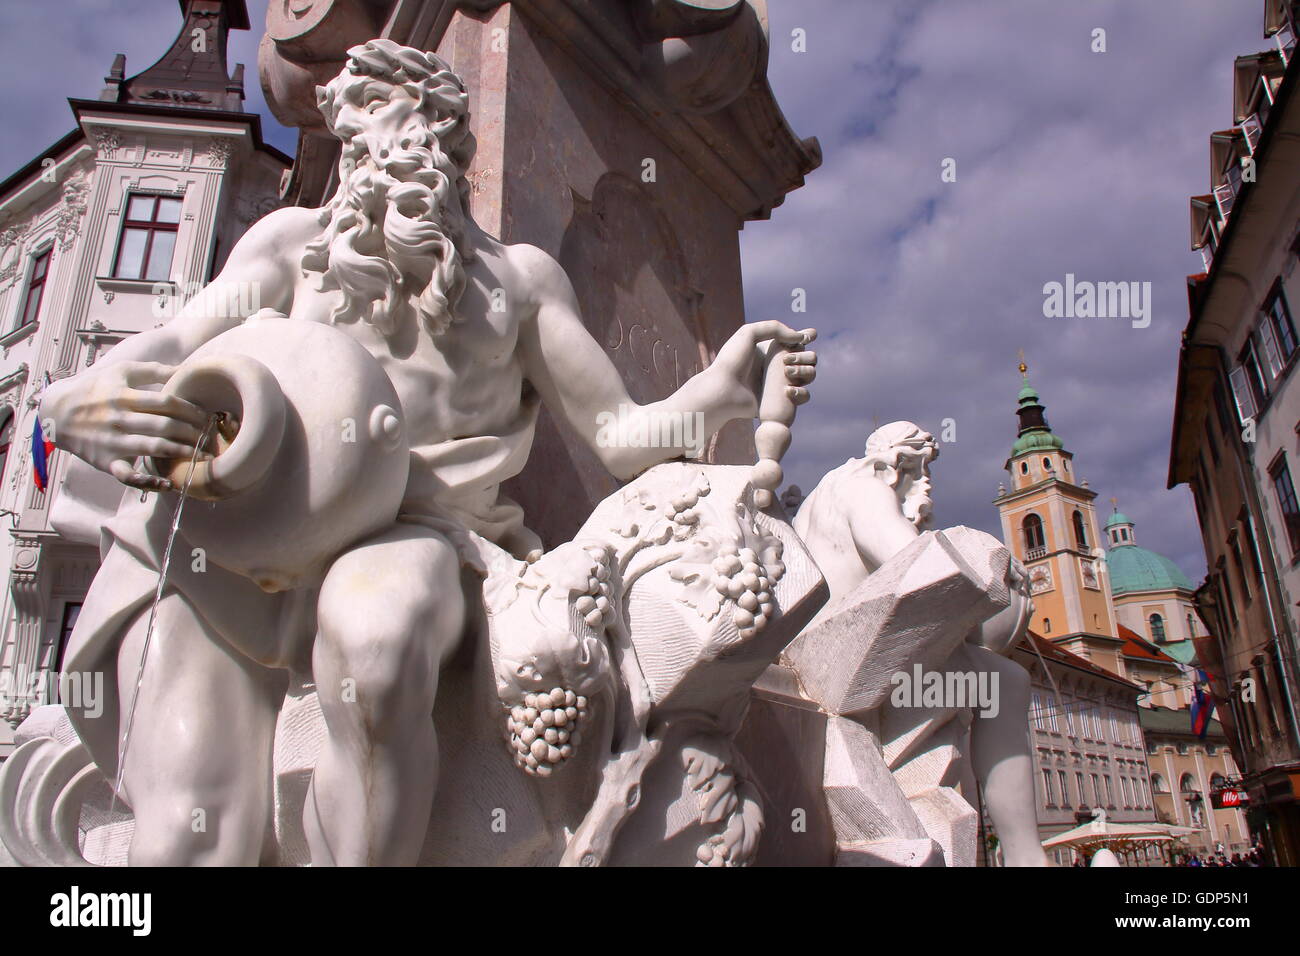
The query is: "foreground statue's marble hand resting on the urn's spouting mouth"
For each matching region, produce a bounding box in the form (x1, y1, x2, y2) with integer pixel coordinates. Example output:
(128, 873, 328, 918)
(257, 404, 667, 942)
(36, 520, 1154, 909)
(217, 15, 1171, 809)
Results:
(40, 362, 208, 490)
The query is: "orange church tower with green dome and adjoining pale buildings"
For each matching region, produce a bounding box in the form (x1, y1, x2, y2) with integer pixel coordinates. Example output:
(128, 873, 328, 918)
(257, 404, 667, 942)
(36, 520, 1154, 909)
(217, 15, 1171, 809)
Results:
(993, 363, 1249, 864)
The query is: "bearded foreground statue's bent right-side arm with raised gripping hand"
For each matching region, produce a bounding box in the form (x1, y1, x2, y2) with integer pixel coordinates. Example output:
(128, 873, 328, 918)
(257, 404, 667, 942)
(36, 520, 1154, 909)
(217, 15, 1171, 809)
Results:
(510, 246, 815, 479)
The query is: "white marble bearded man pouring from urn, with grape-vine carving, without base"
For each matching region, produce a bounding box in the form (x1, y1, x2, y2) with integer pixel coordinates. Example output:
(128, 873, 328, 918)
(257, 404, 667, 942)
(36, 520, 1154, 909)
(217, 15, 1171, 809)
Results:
(22, 40, 818, 865)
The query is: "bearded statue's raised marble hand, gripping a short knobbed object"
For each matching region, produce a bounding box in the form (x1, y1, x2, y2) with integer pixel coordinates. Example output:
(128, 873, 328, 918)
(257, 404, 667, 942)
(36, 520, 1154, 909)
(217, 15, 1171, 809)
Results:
(711, 319, 816, 419)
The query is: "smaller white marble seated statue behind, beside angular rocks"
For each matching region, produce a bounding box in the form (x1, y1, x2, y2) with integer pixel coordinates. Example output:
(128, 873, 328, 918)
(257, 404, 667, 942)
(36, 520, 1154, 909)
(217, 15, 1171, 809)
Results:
(787, 421, 1047, 866)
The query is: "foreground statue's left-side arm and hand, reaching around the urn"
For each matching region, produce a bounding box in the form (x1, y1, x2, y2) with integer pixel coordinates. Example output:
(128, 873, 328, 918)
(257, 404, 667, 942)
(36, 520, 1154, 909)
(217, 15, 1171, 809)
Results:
(40, 208, 320, 489)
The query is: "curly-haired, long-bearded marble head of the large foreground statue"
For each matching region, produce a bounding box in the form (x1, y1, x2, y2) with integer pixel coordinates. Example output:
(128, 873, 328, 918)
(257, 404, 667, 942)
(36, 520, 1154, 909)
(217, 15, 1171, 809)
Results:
(303, 39, 475, 334)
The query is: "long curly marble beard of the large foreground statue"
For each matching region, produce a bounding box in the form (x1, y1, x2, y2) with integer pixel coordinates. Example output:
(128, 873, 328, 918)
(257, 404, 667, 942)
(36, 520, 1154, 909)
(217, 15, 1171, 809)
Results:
(302, 133, 472, 336)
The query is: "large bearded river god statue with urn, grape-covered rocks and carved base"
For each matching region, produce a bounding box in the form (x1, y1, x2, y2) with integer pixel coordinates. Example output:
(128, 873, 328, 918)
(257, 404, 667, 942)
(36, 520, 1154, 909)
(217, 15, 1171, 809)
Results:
(0, 40, 1013, 866)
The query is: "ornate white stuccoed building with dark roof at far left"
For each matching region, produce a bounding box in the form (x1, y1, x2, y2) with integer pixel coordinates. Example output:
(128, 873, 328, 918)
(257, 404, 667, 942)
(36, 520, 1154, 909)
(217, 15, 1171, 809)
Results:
(0, 0, 290, 760)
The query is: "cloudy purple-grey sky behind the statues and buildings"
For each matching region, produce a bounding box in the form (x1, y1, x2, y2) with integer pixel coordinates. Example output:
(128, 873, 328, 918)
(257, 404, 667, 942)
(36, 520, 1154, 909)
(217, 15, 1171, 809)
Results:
(0, 0, 1266, 580)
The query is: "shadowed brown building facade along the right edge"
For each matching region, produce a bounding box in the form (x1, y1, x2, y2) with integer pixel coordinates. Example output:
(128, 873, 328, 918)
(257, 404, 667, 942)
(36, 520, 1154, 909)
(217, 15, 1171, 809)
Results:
(1169, 0, 1300, 866)
